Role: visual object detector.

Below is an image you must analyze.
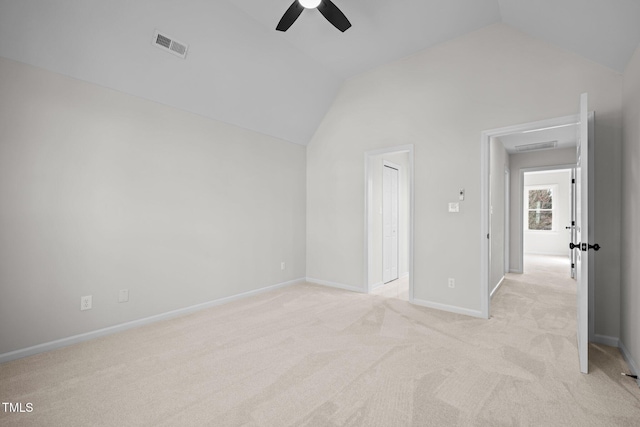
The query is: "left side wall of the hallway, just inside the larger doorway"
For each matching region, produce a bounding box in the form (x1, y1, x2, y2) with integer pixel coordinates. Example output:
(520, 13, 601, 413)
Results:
(489, 138, 509, 294)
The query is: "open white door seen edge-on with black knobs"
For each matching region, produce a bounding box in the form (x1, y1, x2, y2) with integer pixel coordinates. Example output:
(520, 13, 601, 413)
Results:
(570, 93, 600, 374)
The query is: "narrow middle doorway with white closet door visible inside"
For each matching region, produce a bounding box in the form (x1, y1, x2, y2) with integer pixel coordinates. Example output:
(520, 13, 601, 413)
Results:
(363, 145, 414, 301)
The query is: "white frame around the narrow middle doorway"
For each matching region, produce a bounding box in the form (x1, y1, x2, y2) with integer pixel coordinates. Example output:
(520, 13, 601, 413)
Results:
(362, 144, 415, 302)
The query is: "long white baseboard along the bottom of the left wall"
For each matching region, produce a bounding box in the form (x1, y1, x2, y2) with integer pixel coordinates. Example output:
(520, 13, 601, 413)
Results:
(0, 278, 305, 363)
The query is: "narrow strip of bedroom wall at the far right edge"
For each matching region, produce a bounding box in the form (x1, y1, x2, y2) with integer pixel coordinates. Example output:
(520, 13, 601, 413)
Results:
(620, 43, 640, 374)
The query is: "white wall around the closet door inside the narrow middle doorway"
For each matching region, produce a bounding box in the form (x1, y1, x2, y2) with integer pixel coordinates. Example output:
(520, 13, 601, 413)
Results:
(369, 153, 409, 286)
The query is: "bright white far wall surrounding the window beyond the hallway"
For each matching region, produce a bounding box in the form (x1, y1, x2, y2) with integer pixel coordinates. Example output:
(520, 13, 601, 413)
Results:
(522, 170, 571, 257)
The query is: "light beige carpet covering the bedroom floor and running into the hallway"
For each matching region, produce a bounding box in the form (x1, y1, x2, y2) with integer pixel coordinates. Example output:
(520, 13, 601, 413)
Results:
(0, 256, 640, 427)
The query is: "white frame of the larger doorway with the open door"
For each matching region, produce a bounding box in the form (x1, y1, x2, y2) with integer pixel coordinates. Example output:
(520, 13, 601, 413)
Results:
(480, 114, 580, 319)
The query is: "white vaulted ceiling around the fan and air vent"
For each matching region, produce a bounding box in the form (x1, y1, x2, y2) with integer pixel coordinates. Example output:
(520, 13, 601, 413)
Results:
(0, 0, 640, 144)
